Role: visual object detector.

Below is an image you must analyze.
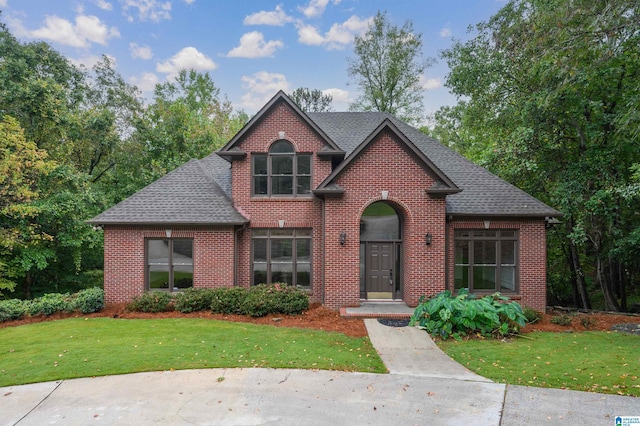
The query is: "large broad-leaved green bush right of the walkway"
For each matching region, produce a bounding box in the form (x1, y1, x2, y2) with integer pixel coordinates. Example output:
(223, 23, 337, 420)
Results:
(410, 289, 526, 339)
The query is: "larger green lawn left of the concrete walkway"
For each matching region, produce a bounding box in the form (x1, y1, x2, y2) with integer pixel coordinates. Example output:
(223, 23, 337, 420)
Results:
(0, 318, 387, 386)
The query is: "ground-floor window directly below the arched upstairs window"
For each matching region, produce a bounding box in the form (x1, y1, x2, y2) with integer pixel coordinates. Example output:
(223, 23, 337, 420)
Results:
(252, 229, 311, 289)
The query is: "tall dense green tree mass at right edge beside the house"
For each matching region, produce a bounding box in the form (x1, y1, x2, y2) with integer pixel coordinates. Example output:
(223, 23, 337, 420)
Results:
(440, 0, 640, 311)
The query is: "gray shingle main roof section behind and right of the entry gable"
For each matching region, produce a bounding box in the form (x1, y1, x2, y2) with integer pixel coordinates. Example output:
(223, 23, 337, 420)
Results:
(309, 112, 561, 217)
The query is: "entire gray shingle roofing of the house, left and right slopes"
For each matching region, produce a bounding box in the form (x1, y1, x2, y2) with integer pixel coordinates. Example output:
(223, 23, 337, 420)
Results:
(89, 103, 561, 225)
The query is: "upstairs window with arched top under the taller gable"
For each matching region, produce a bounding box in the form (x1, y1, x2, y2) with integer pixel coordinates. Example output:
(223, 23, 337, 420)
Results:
(251, 140, 311, 197)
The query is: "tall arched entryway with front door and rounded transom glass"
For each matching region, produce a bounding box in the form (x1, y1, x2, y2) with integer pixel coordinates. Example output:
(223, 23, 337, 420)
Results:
(360, 201, 402, 300)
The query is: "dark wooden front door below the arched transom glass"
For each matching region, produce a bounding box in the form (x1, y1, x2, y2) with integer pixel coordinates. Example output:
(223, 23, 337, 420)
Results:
(364, 242, 400, 299)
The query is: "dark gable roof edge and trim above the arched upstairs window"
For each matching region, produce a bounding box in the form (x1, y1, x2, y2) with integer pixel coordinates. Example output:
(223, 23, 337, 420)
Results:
(218, 90, 344, 159)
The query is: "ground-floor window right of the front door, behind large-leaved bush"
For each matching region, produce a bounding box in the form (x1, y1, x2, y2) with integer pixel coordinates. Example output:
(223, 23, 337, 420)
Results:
(454, 230, 518, 293)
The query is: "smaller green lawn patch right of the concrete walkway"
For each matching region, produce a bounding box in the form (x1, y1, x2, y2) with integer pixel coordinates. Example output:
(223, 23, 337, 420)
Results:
(438, 331, 640, 396)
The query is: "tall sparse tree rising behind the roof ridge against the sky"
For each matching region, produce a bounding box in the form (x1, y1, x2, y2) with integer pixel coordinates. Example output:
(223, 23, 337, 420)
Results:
(347, 12, 433, 122)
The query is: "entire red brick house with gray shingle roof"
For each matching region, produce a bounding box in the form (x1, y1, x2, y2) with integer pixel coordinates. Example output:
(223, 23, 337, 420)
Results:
(89, 92, 560, 310)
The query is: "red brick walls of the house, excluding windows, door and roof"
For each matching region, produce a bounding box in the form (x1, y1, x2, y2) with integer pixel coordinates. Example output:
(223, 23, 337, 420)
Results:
(105, 102, 546, 310)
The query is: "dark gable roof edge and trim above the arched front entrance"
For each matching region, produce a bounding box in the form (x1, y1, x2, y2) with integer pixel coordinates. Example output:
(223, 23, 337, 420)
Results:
(314, 117, 460, 196)
